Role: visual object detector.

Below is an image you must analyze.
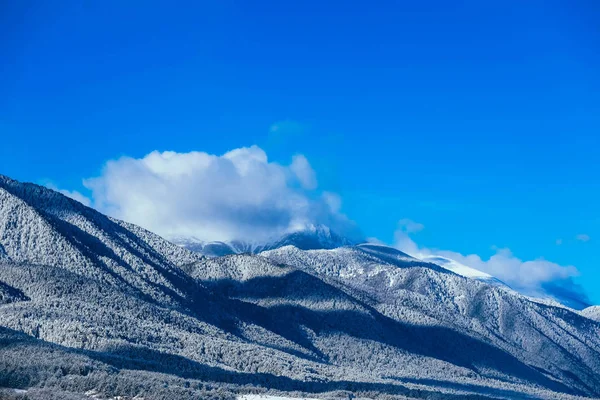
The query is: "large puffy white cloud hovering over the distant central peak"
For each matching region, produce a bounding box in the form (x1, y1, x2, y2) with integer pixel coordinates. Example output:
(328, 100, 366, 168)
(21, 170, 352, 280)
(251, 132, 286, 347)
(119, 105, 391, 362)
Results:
(84, 146, 355, 241)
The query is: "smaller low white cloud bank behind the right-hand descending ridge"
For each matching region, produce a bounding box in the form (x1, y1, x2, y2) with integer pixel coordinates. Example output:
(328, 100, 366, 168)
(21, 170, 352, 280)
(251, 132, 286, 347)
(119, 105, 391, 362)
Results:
(394, 220, 587, 302)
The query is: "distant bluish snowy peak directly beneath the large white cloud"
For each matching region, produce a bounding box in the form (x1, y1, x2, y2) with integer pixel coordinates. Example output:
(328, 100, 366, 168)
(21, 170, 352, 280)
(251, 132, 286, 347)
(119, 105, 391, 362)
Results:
(169, 225, 358, 257)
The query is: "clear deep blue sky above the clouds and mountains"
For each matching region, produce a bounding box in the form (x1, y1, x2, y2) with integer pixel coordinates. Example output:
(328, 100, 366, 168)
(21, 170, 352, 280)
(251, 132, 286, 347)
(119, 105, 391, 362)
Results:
(0, 1, 600, 303)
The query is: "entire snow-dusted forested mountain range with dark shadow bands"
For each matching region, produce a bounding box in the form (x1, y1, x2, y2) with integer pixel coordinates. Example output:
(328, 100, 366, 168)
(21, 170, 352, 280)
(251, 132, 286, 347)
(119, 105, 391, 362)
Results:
(0, 177, 600, 399)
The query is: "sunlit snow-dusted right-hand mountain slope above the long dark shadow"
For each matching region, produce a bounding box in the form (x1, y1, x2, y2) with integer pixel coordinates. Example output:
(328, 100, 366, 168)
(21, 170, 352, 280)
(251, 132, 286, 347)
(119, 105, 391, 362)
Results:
(261, 246, 600, 396)
